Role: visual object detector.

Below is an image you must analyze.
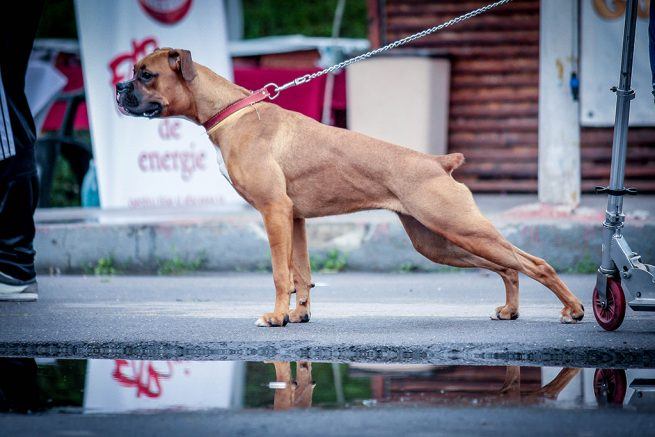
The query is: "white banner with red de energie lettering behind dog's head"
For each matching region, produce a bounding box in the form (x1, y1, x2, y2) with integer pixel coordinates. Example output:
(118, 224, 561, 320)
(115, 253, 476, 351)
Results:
(75, 0, 243, 208)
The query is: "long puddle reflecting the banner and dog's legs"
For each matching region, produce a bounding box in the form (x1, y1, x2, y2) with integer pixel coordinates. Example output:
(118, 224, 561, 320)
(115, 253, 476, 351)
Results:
(0, 358, 655, 414)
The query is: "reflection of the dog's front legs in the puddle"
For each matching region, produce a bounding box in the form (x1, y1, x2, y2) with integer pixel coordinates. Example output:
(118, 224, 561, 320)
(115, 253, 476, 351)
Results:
(273, 361, 316, 410)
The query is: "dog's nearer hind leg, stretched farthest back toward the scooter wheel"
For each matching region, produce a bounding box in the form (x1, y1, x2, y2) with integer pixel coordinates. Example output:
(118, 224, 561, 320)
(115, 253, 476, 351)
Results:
(400, 176, 584, 323)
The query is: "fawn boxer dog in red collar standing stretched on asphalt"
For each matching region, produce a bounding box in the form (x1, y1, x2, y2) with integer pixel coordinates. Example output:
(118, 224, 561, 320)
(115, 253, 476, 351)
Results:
(116, 48, 584, 326)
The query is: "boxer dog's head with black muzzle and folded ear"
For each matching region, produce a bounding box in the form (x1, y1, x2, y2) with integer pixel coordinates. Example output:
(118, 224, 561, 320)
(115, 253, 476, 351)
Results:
(116, 48, 198, 118)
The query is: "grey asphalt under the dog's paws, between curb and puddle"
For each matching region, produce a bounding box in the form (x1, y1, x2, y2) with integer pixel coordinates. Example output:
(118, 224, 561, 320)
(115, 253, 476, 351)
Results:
(0, 272, 655, 367)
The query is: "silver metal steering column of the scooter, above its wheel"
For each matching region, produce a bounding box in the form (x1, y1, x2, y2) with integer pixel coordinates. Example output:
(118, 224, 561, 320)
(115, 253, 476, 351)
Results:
(601, 0, 638, 273)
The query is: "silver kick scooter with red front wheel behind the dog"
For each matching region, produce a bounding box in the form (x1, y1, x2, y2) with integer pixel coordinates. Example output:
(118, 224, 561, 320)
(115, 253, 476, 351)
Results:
(593, 0, 655, 331)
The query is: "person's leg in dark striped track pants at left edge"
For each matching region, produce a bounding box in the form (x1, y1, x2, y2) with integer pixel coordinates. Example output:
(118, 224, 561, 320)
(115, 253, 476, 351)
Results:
(0, 1, 43, 300)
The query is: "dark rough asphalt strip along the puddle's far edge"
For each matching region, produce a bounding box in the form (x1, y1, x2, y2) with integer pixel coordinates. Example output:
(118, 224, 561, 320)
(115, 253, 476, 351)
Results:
(0, 341, 655, 368)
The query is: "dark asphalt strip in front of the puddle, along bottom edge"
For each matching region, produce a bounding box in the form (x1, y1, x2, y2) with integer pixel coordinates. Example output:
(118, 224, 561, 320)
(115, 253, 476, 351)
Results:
(0, 407, 655, 437)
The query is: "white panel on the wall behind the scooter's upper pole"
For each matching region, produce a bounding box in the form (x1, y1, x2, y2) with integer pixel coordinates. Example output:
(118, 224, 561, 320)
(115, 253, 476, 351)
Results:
(580, 0, 655, 127)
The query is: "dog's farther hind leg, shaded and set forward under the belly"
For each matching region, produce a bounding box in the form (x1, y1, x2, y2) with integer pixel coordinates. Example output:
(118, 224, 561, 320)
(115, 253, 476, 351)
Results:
(398, 214, 519, 320)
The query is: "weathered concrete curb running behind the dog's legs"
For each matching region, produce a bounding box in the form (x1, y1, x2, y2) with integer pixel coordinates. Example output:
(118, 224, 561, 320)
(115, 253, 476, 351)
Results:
(35, 207, 655, 273)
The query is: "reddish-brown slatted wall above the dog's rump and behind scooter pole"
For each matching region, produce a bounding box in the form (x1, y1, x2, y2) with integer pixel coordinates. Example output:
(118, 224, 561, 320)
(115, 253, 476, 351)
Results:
(376, 0, 655, 192)
